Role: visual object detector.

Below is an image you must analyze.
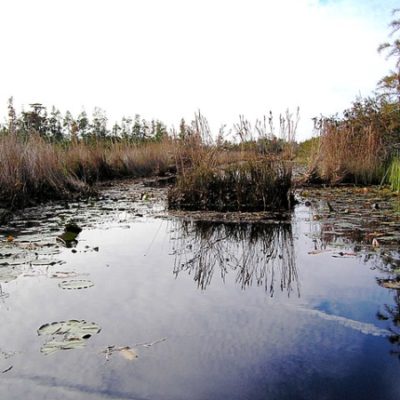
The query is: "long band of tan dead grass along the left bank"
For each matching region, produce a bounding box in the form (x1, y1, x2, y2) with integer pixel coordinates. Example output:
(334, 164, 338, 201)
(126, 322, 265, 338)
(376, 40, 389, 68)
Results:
(0, 134, 172, 207)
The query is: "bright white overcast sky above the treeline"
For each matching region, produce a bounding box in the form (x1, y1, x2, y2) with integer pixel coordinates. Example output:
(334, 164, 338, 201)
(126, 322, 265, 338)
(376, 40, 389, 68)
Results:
(0, 0, 399, 139)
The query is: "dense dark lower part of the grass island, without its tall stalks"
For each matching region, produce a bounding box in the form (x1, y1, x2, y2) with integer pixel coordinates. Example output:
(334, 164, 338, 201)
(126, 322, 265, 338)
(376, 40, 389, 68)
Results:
(168, 161, 291, 212)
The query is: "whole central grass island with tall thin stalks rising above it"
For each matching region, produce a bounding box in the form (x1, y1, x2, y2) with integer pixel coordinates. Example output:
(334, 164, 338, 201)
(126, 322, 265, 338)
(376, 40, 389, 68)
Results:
(168, 114, 294, 212)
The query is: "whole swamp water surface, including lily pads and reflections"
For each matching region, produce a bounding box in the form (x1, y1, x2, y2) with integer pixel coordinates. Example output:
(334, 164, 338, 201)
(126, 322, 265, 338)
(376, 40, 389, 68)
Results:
(0, 183, 400, 400)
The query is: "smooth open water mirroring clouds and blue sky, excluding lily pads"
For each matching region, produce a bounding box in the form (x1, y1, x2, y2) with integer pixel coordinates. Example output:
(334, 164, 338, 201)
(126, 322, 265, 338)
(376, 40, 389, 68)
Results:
(0, 206, 399, 400)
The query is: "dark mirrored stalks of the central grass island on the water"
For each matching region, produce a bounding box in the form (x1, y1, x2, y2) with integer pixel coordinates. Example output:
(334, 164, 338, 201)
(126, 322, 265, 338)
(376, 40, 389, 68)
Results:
(170, 221, 300, 296)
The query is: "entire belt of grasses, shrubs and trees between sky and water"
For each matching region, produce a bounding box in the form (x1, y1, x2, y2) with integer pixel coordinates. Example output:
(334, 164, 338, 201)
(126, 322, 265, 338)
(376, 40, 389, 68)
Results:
(0, 10, 400, 216)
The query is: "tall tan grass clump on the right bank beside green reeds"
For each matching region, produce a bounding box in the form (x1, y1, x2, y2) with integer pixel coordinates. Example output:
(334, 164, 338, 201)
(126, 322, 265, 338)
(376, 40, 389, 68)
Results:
(308, 99, 390, 185)
